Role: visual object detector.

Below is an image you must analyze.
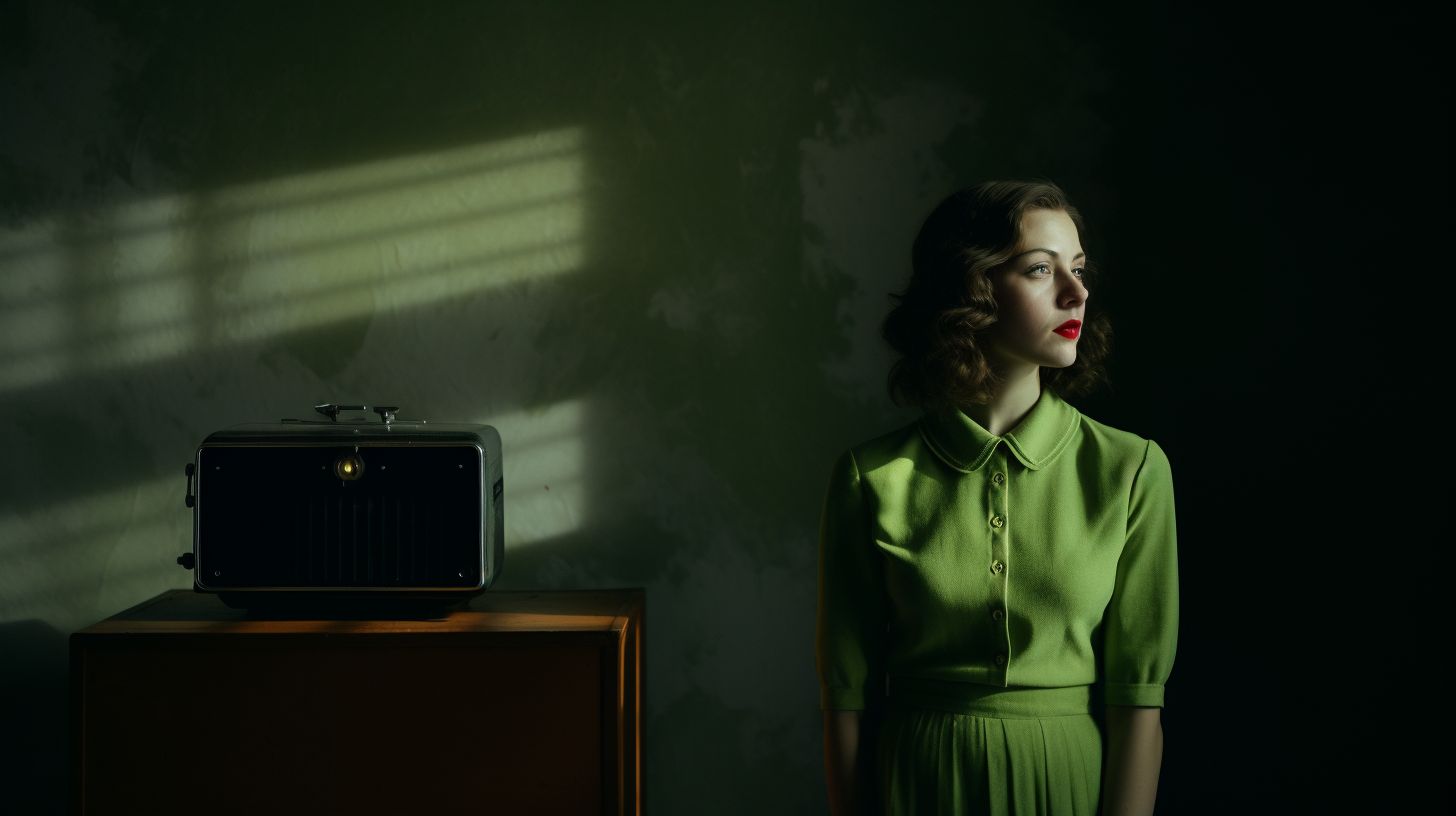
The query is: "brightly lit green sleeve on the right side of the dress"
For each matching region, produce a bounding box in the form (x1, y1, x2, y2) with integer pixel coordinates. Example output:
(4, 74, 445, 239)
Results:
(1102, 440, 1178, 707)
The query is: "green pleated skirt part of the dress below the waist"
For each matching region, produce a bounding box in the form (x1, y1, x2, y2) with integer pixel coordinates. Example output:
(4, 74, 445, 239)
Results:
(877, 679, 1102, 816)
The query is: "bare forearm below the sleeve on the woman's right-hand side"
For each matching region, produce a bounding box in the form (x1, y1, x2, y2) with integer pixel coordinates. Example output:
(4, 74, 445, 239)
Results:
(1102, 705, 1163, 816)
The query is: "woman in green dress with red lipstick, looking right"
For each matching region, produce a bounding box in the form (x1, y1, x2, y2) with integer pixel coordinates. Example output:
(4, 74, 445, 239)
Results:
(817, 182, 1178, 816)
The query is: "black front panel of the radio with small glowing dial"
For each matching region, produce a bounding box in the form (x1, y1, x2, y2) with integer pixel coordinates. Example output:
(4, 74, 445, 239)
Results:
(197, 446, 482, 590)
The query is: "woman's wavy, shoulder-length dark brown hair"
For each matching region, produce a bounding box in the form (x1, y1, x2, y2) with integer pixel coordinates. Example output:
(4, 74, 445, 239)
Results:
(881, 181, 1112, 408)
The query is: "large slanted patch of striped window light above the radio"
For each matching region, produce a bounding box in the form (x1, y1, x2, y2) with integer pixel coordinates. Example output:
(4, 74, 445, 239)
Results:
(0, 128, 584, 391)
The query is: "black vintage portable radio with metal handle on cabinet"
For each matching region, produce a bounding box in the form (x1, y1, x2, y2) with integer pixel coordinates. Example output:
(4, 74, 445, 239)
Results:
(178, 404, 505, 606)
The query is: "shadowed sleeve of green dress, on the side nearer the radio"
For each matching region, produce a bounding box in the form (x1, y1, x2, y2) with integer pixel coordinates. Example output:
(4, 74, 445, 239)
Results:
(815, 452, 885, 711)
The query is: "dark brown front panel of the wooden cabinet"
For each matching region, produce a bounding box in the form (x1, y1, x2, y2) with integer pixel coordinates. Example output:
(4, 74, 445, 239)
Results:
(77, 632, 602, 816)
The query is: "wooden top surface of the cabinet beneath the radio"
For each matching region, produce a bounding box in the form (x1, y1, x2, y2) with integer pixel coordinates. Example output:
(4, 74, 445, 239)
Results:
(76, 589, 644, 635)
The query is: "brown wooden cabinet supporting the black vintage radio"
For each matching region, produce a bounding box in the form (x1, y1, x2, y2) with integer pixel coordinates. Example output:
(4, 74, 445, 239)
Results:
(70, 590, 644, 816)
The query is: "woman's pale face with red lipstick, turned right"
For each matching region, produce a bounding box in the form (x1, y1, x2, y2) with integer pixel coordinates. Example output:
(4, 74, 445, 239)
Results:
(986, 210, 1088, 377)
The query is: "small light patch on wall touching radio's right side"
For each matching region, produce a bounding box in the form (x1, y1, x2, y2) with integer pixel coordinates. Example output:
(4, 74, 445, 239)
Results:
(475, 399, 587, 547)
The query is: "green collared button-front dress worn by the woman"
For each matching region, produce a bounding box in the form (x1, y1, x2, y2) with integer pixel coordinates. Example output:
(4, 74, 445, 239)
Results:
(817, 389, 1178, 816)
